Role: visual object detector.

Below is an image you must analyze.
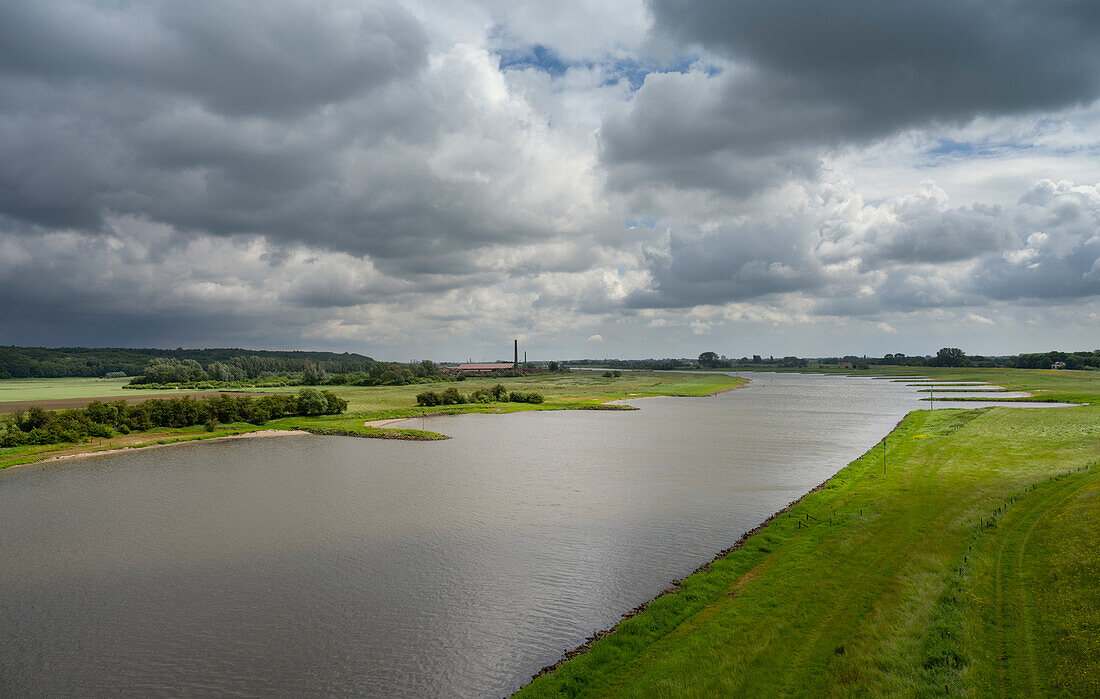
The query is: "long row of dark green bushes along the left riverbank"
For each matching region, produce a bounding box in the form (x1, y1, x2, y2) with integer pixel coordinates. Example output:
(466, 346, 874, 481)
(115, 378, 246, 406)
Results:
(0, 387, 348, 447)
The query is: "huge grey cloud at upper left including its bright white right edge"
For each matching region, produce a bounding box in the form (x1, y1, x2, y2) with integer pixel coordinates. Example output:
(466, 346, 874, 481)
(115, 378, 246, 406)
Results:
(0, 0, 594, 280)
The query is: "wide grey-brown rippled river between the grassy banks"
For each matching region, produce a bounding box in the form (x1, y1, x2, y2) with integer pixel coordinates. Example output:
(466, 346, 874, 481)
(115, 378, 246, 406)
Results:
(0, 373, 1069, 697)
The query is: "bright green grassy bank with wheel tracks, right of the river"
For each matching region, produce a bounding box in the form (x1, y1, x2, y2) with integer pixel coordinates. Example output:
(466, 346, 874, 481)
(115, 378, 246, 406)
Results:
(518, 385, 1100, 698)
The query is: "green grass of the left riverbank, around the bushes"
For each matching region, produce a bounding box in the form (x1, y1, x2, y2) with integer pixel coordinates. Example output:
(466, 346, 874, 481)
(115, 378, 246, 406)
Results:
(0, 371, 746, 469)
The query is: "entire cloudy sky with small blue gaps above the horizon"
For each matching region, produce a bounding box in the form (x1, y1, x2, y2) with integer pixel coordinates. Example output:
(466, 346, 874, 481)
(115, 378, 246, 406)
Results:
(0, 0, 1100, 360)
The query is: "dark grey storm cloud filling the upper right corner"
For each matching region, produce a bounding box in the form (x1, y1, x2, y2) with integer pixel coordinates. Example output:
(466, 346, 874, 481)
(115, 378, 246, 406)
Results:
(602, 0, 1100, 195)
